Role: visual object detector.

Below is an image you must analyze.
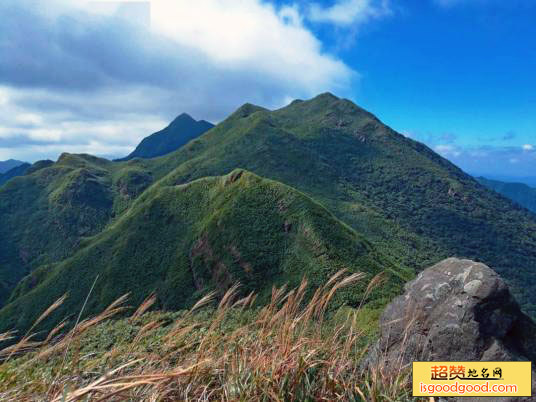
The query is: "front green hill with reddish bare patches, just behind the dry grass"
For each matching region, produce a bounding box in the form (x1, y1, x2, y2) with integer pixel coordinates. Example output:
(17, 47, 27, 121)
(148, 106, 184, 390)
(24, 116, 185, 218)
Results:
(0, 170, 402, 331)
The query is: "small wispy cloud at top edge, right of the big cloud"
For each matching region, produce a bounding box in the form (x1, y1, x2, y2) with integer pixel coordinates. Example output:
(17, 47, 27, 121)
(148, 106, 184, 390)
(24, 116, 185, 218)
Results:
(309, 0, 391, 26)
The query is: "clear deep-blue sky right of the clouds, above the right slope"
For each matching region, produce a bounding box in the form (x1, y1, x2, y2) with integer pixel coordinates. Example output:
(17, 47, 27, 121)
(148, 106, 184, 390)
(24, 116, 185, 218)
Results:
(326, 0, 536, 175)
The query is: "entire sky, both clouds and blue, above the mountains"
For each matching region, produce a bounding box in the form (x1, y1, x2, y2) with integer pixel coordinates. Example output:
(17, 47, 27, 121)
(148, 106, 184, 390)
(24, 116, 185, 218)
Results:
(0, 0, 536, 177)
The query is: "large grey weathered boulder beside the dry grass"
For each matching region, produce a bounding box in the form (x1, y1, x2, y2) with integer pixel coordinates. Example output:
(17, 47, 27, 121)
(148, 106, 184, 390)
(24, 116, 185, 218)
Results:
(367, 258, 536, 400)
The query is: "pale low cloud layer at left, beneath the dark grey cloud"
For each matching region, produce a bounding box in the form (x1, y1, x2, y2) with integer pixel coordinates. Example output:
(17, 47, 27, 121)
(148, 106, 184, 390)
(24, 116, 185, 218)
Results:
(0, 87, 169, 162)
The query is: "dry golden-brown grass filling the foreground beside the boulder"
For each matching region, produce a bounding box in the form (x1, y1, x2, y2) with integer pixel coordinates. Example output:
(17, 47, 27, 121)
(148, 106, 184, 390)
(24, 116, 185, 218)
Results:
(0, 271, 410, 402)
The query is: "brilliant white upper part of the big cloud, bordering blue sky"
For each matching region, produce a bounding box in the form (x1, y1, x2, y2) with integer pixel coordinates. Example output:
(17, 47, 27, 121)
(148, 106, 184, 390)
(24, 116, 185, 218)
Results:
(151, 0, 351, 92)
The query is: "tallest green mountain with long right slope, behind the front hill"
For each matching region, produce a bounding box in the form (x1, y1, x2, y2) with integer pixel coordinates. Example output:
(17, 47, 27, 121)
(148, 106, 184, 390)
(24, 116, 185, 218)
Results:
(141, 94, 536, 314)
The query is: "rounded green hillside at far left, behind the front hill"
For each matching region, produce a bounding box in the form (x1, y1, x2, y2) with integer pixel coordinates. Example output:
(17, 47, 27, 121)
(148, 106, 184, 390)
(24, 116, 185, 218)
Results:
(0, 154, 152, 306)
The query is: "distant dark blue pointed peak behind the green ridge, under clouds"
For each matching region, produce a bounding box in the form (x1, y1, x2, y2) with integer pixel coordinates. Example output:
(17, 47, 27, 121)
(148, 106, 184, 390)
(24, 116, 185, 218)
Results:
(118, 113, 214, 161)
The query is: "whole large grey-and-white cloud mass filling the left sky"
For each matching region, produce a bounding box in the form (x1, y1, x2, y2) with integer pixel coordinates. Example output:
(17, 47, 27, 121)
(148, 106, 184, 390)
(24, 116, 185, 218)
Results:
(0, 0, 358, 160)
